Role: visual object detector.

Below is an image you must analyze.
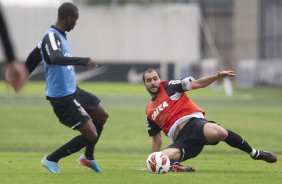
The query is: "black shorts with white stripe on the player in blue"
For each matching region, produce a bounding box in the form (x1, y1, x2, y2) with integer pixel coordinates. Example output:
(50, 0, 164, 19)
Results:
(47, 88, 100, 130)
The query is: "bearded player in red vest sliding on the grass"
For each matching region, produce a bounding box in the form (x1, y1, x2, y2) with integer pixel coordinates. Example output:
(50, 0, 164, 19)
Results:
(143, 68, 278, 172)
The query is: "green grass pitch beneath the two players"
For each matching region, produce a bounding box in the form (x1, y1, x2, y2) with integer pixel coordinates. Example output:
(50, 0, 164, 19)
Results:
(0, 82, 282, 184)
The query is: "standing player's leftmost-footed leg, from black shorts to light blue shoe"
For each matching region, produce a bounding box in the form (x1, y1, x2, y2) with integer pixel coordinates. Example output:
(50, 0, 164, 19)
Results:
(41, 97, 98, 173)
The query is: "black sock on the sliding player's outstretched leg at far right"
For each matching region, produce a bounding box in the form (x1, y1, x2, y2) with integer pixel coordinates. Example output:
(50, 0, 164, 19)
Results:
(224, 130, 253, 154)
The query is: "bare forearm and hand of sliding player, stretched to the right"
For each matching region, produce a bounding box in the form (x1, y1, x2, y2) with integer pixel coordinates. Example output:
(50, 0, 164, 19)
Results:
(191, 71, 236, 89)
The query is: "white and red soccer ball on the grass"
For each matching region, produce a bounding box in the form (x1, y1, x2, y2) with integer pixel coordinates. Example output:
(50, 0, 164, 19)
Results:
(146, 152, 170, 174)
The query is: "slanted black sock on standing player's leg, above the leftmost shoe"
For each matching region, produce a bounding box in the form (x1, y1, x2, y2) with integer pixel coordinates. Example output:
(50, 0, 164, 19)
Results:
(47, 135, 90, 162)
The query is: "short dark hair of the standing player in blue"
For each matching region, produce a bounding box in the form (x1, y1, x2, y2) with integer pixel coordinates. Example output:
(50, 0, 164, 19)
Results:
(58, 2, 78, 20)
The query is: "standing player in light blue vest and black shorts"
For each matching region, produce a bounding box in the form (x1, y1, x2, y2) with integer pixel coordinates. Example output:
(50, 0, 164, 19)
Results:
(26, 2, 108, 173)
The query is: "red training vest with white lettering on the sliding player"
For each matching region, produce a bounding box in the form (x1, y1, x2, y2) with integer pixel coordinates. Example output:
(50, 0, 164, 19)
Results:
(146, 82, 205, 135)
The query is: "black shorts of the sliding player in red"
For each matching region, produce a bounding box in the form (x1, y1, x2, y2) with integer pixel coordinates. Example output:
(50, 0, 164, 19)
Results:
(168, 118, 218, 161)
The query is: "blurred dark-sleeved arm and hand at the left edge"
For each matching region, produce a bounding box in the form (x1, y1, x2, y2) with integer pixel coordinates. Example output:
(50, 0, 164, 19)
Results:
(0, 7, 27, 92)
